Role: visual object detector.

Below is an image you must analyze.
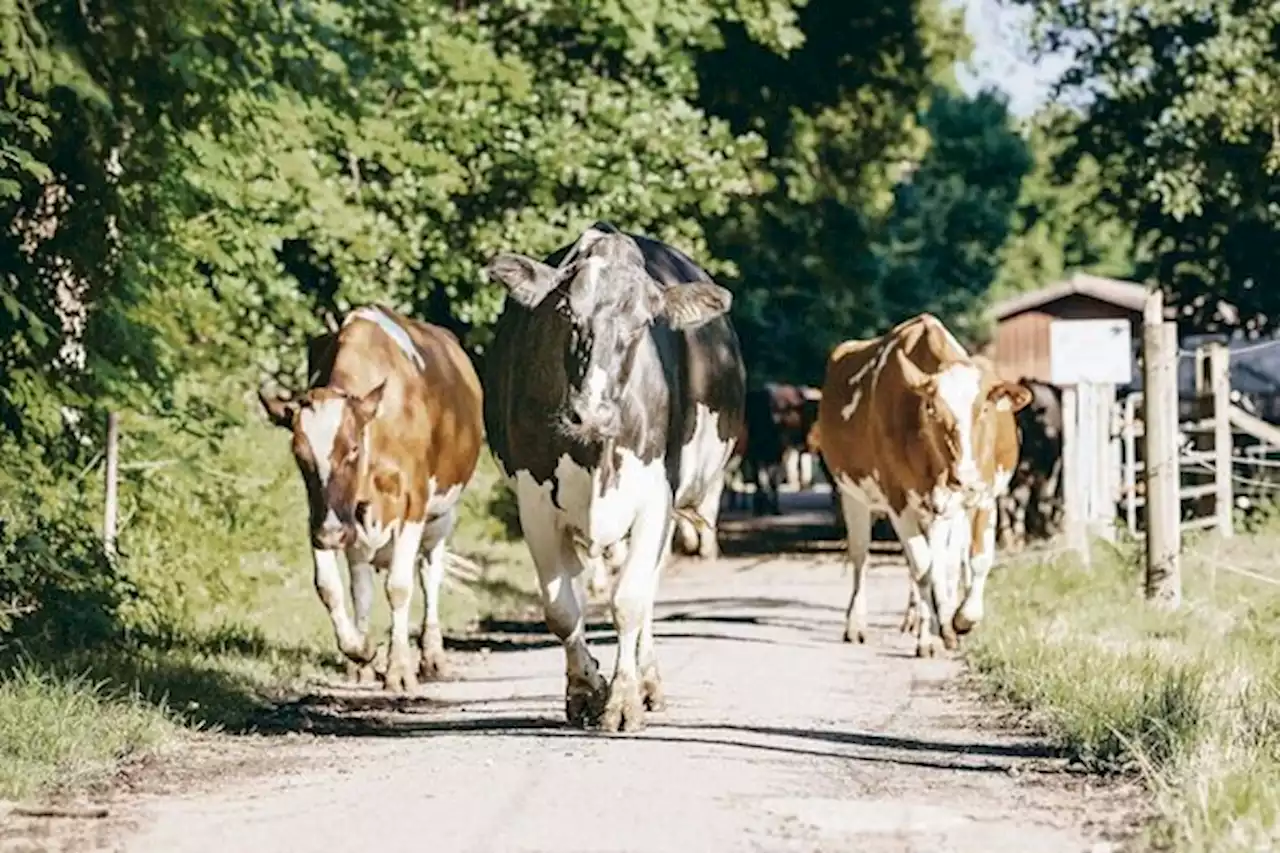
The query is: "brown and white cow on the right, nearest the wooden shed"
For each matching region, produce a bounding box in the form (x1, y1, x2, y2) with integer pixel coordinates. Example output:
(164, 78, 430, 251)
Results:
(818, 314, 1025, 657)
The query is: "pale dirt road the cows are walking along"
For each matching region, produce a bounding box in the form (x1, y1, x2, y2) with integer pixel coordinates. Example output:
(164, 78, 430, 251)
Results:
(22, 494, 1141, 853)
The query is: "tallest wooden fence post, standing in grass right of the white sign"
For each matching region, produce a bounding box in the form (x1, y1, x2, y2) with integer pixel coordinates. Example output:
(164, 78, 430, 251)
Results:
(1142, 288, 1183, 610)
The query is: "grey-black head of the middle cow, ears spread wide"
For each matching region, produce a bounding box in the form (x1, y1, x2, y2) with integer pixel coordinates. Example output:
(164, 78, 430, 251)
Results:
(485, 228, 732, 443)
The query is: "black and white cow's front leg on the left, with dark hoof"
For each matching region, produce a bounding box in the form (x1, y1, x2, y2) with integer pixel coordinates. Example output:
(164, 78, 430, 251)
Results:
(520, 489, 608, 729)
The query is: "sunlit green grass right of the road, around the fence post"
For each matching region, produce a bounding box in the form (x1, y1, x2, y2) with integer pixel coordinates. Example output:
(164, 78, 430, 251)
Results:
(969, 528, 1280, 853)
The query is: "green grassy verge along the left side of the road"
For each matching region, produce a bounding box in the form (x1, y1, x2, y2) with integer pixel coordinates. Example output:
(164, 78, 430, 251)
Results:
(0, 389, 536, 799)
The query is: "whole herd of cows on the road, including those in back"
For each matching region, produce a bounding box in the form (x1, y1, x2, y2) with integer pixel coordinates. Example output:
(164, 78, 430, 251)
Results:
(260, 223, 1070, 731)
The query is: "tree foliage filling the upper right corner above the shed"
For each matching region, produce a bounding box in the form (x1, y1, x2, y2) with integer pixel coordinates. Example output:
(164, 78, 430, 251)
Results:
(1014, 0, 1280, 329)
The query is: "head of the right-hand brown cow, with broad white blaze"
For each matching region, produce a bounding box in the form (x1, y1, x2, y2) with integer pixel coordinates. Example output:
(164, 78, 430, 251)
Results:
(897, 350, 1032, 506)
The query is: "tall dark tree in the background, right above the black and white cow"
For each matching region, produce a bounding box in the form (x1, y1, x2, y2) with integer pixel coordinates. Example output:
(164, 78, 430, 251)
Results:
(698, 0, 968, 383)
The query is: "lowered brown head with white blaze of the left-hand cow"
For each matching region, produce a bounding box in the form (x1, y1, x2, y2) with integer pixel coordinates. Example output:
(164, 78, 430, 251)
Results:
(259, 382, 385, 549)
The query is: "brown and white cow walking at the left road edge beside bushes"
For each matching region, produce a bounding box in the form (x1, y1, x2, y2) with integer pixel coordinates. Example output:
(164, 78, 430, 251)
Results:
(260, 306, 484, 692)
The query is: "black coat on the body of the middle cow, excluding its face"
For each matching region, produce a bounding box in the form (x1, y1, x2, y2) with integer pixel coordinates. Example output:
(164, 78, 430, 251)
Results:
(484, 223, 746, 506)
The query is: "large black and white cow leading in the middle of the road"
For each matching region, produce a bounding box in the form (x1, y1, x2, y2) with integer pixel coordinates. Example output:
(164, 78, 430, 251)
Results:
(484, 223, 746, 731)
